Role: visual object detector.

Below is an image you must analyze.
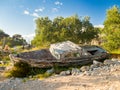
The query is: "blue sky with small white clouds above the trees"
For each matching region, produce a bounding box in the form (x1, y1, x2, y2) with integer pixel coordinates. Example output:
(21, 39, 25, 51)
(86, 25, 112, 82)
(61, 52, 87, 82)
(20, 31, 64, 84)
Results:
(0, 0, 120, 35)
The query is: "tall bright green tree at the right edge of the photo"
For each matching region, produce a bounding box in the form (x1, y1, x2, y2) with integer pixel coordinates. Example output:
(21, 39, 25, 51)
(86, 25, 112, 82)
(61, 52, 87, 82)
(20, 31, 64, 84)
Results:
(103, 6, 120, 51)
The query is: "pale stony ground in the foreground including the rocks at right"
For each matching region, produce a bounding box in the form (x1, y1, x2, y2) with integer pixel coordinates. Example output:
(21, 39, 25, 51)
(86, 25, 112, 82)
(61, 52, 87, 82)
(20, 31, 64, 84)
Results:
(0, 60, 120, 90)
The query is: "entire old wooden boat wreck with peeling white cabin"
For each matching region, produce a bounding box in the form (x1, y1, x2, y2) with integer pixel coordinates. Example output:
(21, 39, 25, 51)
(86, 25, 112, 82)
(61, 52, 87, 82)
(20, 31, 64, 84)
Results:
(9, 41, 109, 68)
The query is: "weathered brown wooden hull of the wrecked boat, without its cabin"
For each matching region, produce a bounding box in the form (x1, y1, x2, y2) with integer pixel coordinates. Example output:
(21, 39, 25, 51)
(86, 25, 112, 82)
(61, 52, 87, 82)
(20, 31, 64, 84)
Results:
(9, 49, 106, 68)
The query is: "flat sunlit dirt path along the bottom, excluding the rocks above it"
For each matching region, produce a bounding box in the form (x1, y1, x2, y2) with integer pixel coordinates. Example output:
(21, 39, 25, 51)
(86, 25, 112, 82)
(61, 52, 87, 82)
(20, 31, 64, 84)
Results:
(0, 71, 120, 90)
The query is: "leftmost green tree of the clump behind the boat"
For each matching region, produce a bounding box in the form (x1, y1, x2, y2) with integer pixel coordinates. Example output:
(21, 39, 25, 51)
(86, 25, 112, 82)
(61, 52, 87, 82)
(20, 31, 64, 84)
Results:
(32, 17, 52, 46)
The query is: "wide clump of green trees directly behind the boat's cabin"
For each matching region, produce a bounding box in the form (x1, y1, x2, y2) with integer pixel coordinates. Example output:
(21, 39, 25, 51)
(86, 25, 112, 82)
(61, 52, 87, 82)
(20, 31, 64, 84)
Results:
(32, 15, 97, 46)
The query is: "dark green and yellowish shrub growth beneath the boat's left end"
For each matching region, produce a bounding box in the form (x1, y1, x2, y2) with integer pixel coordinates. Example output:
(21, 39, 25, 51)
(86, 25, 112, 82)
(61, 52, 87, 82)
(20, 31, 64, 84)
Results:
(4, 62, 52, 78)
